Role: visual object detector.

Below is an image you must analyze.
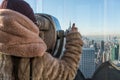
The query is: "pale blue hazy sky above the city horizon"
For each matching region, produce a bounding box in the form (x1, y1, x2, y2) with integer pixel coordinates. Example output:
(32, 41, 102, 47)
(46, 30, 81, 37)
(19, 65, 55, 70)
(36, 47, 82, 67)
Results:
(0, 0, 120, 35)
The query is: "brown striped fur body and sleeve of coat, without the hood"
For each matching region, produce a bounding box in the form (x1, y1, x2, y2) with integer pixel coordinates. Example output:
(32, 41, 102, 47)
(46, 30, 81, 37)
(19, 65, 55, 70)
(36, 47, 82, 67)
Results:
(0, 9, 83, 80)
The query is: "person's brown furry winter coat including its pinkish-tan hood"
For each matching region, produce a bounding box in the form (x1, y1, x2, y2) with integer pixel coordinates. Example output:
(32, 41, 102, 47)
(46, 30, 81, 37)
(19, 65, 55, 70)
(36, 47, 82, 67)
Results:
(0, 10, 83, 80)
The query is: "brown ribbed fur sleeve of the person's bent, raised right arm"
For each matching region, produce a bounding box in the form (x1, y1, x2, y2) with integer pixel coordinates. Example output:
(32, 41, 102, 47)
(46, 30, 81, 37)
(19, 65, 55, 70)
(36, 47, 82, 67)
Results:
(43, 32, 83, 80)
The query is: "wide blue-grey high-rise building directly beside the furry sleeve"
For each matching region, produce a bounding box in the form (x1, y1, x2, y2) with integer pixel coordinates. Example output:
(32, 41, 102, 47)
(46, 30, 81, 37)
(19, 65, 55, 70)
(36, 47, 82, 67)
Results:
(79, 48, 96, 78)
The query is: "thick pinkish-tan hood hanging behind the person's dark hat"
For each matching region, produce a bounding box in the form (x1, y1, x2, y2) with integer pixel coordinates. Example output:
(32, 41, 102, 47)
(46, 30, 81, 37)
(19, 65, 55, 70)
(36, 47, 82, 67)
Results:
(0, 9, 47, 57)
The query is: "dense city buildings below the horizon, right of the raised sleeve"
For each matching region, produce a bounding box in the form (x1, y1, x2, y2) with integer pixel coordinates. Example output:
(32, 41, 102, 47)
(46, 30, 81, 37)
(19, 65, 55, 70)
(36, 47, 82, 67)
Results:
(79, 35, 120, 78)
